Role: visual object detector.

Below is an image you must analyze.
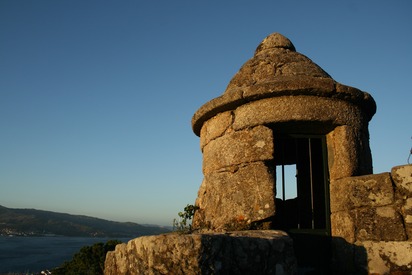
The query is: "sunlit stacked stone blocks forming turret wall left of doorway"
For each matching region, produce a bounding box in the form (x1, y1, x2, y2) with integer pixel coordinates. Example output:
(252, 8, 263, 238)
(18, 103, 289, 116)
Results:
(193, 124, 275, 230)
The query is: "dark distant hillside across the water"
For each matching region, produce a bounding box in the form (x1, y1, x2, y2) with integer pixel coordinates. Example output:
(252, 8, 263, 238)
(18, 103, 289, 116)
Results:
(0, 205, 169, 238)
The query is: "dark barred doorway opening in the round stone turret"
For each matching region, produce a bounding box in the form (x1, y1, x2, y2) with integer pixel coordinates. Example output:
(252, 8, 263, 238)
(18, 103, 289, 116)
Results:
(273, 134, 331, 274)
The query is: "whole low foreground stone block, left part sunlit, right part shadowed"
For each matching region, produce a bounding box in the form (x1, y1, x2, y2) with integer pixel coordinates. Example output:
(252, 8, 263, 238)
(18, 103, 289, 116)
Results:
(104, 231, 297, 275)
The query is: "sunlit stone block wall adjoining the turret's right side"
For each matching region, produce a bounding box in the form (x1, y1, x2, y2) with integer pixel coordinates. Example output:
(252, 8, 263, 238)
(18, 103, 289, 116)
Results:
(330, 165, 412, 274)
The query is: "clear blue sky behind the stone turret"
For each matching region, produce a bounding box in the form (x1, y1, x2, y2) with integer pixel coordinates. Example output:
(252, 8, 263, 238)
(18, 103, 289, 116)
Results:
(0, 0, 412, 225)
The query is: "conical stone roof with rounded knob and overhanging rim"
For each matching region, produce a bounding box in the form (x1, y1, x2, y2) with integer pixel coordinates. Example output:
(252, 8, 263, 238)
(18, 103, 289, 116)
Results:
(192, 33, 376, 136)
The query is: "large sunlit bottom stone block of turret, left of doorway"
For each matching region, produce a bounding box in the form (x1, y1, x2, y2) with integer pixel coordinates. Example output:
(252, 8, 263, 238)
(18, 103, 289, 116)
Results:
(193, 162, 275, 230)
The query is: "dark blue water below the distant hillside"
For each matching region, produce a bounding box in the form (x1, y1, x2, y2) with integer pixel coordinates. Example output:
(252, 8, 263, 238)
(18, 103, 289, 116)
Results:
(0, 236, 130, 274)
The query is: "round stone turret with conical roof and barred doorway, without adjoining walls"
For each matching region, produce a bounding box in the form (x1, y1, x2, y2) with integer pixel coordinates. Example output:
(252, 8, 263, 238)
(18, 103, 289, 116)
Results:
(192, 33, 376, 234)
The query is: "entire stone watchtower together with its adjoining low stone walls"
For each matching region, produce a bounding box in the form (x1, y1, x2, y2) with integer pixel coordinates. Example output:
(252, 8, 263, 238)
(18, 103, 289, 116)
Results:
(105, 33, 412, 275)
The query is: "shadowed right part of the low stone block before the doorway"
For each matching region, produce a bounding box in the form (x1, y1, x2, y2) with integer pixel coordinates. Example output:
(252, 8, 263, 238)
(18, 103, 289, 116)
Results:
(199, 231, 297, 275)
